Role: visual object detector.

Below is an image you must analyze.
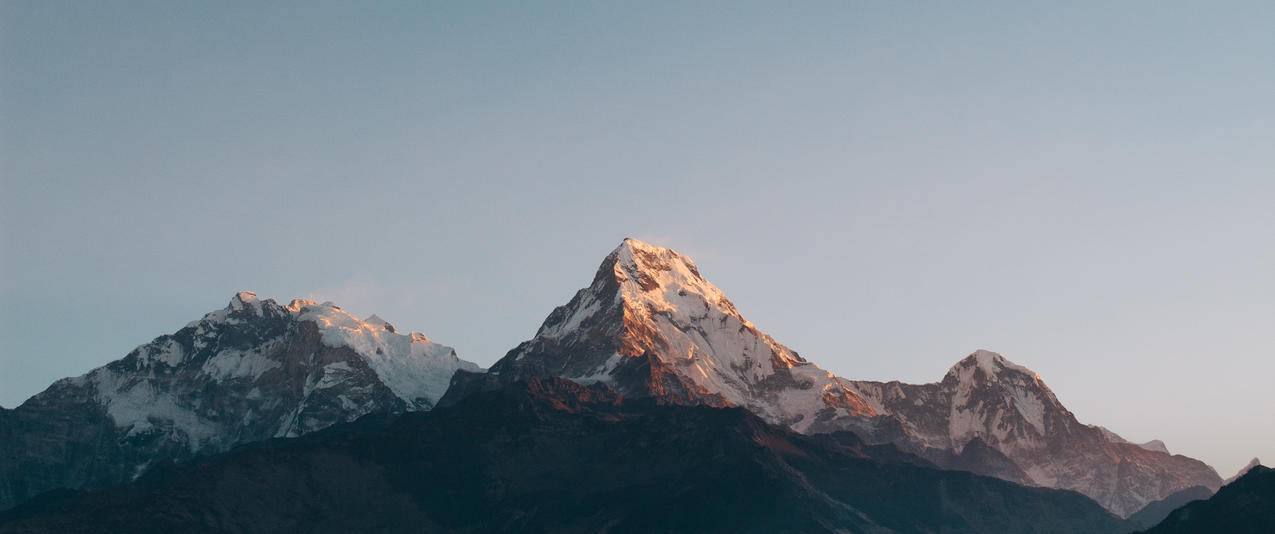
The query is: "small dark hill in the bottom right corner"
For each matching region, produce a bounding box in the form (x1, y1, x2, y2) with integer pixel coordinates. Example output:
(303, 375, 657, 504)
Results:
(1146, 465, 1275, 534)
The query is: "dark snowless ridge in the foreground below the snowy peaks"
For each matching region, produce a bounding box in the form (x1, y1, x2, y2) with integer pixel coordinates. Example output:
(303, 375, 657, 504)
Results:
(0, 377, 1127, 533)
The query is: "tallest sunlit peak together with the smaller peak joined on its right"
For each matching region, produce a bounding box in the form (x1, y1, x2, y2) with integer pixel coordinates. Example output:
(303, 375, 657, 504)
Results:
(464, 240, 1221, 515)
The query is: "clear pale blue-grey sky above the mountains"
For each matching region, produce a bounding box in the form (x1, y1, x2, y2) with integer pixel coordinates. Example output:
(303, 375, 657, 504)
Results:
(0, 0, 1275, 475)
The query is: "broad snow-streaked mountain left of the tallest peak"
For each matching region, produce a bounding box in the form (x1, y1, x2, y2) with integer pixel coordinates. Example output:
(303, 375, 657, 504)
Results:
(0, 292, 479, 510)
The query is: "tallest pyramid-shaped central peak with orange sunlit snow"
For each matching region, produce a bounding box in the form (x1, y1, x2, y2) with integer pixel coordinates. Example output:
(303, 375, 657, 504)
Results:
(491, 238, 871, 431)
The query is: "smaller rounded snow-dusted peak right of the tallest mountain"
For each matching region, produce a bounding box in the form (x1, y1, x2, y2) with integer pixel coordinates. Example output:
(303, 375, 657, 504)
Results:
(852, 350, 1221, 516)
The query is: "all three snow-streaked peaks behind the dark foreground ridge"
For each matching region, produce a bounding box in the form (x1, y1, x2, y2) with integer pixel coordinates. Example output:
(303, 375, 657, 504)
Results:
(0, 240, 1221, 516)
